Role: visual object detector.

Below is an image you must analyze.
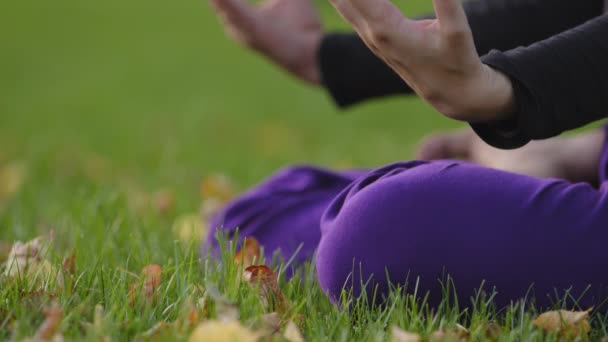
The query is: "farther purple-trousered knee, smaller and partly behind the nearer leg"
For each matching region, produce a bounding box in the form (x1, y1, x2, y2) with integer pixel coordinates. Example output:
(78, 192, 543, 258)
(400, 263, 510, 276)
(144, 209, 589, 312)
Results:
(202, 166, 366, 263)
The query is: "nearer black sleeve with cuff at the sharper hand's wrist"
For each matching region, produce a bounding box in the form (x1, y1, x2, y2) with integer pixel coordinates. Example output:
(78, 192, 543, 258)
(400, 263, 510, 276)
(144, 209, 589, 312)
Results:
(471, 15, 608, 148)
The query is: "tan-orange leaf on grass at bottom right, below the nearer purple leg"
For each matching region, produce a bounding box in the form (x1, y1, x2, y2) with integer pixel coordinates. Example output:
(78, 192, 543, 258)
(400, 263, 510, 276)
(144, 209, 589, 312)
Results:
(534, 309, 591, 336)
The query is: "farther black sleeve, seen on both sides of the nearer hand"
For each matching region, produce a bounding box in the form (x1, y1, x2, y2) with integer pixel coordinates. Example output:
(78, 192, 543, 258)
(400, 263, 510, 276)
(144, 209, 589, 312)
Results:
(318, 0, 603, 106)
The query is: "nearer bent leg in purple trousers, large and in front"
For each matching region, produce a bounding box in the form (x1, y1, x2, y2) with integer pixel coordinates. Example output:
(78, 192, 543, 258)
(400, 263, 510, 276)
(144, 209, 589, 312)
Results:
(316, 158, 608, 307)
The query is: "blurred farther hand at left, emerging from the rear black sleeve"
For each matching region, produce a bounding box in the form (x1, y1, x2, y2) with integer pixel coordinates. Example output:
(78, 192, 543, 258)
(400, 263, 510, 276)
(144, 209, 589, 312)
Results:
(211, 0, 323, 84)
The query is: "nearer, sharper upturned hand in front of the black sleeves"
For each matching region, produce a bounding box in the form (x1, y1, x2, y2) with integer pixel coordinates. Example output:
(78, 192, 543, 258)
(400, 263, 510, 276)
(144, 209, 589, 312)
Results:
(331, 0, 513, 122)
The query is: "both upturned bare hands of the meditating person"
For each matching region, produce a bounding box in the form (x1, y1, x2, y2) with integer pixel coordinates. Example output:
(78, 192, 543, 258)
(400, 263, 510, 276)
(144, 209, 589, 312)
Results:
(211, 0, 513, 122)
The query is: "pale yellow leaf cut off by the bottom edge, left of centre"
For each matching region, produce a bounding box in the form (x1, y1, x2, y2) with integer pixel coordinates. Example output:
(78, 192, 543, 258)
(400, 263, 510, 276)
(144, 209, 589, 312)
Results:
(188, 321, 260, 342)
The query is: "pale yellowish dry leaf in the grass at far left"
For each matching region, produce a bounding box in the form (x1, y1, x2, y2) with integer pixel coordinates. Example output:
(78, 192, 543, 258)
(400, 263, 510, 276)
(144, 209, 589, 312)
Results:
(4, 237, 53, 279)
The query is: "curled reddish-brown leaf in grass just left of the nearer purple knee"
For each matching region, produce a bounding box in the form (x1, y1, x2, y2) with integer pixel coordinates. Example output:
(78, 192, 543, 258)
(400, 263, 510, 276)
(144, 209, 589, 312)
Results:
(243, 265, 287, 315)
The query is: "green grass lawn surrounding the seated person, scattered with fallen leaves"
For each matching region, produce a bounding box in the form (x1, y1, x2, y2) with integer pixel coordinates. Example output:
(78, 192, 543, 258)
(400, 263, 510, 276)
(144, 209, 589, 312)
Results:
(0, 0, 606, 341)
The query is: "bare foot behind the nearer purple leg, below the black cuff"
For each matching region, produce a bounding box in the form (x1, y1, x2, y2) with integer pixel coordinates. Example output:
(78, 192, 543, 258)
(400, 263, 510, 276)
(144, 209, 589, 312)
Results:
(417, 129, 605, 183)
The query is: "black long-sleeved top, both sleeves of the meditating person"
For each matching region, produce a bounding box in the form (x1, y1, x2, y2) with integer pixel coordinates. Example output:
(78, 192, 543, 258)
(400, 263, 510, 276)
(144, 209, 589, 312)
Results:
(319, 0, 608, 148)
